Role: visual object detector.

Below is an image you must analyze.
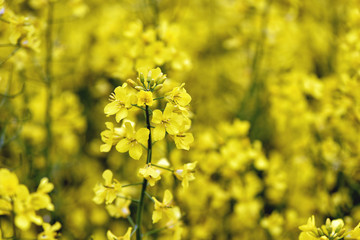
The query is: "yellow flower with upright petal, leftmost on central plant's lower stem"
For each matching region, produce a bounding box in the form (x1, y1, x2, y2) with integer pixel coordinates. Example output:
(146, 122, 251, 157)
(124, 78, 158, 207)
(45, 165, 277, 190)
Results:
(93, 169, 121, 204)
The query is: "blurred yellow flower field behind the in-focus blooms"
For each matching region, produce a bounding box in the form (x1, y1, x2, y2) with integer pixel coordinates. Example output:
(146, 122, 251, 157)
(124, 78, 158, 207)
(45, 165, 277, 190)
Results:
(0, 0, 360, 240)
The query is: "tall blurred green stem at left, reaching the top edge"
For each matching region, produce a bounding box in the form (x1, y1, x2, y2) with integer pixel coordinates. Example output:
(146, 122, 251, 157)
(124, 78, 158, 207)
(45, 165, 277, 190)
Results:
(44, 1, 54, 176)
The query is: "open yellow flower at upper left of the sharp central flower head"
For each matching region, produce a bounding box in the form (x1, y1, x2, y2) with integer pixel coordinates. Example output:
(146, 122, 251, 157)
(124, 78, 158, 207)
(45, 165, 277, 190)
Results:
(104, 83, 132, 122)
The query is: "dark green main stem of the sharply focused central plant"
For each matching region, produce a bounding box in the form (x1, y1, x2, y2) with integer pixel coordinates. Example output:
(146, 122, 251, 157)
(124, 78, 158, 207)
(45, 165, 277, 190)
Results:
(136, 105, 152, 240)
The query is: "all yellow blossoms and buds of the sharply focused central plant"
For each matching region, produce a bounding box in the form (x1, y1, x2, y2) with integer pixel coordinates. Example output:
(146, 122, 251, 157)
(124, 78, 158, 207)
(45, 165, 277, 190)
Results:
(93, 68, 196, 240)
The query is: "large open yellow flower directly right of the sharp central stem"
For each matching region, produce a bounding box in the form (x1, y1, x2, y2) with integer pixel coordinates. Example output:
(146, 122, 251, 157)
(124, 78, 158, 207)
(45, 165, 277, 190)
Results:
(152, 103, 183, 141)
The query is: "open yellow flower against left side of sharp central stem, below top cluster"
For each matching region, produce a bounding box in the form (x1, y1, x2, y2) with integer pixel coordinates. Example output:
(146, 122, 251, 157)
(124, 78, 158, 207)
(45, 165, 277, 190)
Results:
(116, 122, 149, 160)
